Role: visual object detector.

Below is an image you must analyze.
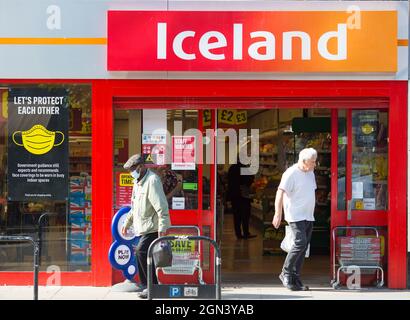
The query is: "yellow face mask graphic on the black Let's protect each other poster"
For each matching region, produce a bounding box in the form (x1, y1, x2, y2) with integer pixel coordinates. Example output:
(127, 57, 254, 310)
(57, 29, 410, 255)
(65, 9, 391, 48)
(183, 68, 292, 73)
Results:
(13, 124, 64, 155)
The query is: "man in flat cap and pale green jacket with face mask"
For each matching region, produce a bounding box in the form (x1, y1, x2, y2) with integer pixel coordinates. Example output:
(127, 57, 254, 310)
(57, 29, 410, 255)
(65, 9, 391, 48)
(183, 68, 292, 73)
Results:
(121, 154, 171, 298)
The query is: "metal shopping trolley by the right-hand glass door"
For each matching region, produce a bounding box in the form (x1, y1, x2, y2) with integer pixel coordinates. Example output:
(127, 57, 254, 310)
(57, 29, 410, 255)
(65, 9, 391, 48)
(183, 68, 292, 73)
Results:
(331, 227, 384, 289)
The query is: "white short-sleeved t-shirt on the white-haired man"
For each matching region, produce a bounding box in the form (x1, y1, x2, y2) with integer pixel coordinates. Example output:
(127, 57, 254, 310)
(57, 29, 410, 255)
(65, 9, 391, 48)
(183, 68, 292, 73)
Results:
(279, 164, 317, 222)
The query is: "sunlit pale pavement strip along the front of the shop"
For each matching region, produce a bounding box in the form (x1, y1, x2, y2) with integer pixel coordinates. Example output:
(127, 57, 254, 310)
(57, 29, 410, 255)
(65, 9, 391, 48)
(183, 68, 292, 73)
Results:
(0, 284, 410, 301)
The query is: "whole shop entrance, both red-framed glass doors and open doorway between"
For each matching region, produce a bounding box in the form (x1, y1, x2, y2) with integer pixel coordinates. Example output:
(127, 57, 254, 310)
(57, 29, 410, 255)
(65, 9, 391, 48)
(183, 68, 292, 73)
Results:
(114, 100, 388, 287)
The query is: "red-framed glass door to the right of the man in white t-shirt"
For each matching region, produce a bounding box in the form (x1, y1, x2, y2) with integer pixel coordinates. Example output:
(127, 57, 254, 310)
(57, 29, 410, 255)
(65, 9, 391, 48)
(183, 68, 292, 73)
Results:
(331, 109, 389, 279)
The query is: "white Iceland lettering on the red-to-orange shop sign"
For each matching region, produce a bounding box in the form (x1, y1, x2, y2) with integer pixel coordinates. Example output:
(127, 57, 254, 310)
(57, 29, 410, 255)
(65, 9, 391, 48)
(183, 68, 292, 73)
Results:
(157, 22, 347, 61)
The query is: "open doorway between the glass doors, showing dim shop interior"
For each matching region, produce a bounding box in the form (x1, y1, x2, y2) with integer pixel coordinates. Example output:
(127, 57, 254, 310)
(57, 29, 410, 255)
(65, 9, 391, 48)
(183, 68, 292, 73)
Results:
(217, 108, 331, 285)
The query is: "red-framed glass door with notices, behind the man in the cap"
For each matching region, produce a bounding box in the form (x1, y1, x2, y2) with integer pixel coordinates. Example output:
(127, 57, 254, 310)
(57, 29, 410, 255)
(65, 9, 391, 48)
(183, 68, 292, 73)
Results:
(113, 102, 215, 283)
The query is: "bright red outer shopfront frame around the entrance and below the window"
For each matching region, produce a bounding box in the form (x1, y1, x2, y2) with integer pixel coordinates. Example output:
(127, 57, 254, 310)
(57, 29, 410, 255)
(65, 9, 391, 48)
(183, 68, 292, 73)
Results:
(0, 80, 407, 289)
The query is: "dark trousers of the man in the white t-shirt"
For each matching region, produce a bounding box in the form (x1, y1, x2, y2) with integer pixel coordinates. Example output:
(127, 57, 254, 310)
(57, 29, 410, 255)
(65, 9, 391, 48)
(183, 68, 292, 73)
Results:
(282, 220, 313, 278)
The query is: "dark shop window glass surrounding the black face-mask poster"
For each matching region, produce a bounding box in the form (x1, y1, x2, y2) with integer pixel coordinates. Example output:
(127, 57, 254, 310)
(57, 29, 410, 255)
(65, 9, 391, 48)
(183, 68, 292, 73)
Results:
(0, 84, 92, 271)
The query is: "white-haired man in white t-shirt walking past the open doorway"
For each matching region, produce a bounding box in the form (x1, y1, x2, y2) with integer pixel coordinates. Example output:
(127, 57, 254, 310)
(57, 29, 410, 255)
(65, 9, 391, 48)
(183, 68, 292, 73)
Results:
(272, 148, 317, 291)
